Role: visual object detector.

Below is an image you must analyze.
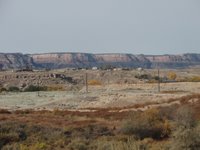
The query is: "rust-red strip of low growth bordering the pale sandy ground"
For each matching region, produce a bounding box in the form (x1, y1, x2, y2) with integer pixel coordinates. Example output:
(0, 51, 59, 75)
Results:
(0, 94, 197, 127)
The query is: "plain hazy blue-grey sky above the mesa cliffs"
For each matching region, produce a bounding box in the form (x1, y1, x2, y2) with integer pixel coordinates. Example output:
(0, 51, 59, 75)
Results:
(0, 0, 200, 54)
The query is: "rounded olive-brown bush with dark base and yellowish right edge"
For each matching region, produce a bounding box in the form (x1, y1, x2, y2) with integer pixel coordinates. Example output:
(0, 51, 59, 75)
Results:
(121, 109, 171, 139)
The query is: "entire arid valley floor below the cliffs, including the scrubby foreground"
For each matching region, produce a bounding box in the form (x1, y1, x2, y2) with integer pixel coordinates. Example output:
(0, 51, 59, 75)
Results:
(0, 67, 200, 150)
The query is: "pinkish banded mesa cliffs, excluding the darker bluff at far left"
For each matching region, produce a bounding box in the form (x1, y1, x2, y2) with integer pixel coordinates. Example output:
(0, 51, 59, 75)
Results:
(31, 53, 200, 68)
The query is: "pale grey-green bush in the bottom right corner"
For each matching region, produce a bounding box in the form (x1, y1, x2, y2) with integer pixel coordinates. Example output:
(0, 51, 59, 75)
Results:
(170, 106, 200, 150)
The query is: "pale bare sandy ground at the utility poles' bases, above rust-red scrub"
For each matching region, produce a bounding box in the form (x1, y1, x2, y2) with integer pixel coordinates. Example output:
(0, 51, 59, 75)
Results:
(0, 82, 200, 110)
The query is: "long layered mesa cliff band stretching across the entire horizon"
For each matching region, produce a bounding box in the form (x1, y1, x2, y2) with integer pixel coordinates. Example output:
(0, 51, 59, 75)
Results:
(0, 53, 200, 69)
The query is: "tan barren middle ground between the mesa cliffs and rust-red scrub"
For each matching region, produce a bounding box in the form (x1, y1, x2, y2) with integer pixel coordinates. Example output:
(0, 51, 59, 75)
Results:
(0, 68, 200, 111)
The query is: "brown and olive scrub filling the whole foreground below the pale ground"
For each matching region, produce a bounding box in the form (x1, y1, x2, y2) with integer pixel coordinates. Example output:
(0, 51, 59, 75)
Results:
(0, 94, 200, 150)
